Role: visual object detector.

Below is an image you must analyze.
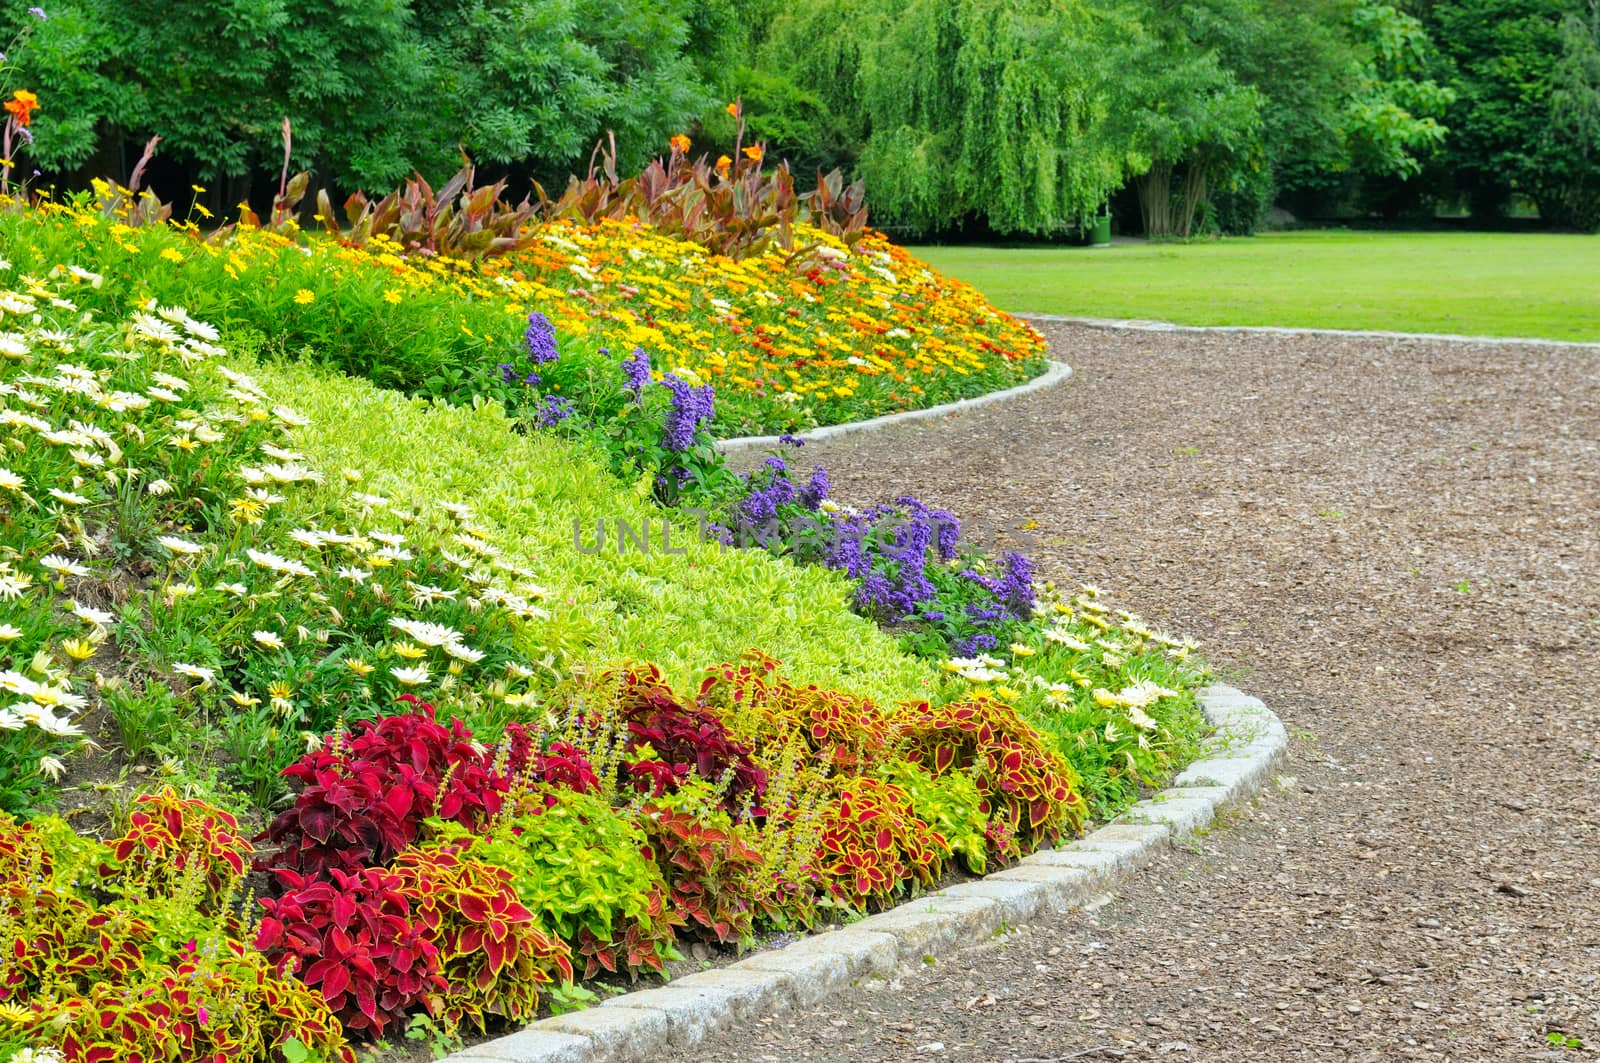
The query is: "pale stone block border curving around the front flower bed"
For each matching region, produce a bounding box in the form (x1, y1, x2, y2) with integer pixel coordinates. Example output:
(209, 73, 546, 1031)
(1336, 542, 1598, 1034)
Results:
(446, 685, 1288, 1063)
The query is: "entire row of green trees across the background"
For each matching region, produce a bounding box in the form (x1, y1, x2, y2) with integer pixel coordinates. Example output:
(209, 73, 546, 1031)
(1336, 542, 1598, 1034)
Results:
(9, 0, 1600, 237)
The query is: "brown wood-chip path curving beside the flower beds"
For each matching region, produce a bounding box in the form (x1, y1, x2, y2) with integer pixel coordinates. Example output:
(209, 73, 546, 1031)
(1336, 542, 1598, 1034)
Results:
(683, 325, 1600, 1063)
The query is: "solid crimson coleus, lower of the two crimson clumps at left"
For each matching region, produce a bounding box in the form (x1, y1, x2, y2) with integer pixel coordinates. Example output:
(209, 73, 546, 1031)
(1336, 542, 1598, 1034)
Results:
(256, 868, 450, 1037)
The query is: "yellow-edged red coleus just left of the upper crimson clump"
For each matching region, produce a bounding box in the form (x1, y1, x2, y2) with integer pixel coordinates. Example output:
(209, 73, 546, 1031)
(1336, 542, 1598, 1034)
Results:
(101, 788, 254, 911)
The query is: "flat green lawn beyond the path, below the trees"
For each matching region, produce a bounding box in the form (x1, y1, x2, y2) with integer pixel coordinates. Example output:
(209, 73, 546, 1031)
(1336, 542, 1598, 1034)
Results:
(912, 231, 1600, 339)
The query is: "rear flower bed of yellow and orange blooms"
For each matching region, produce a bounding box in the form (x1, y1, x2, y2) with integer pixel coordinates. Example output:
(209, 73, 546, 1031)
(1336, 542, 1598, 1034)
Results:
(0, 194, 1045, 435)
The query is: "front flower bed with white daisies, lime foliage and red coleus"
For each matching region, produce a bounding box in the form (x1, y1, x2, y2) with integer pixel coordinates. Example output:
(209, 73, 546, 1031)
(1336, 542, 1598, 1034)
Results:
(0, 243, 1202, 1060)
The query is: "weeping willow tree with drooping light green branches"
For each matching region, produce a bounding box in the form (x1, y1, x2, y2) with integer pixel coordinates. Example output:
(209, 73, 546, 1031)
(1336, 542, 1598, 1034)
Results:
(763, 0, 1131, 234)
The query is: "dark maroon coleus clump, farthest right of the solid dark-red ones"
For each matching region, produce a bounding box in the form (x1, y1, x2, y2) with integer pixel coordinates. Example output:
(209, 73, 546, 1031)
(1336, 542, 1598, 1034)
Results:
(618, 664, 766, 812)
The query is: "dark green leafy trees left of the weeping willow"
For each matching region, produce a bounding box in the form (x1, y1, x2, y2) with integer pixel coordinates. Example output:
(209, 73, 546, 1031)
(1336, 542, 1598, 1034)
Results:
(0, 0, 725, 188)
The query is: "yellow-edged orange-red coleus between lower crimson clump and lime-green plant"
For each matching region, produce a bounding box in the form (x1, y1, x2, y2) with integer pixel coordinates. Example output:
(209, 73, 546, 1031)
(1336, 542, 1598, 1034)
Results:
(394, 842, 573, 1031)
